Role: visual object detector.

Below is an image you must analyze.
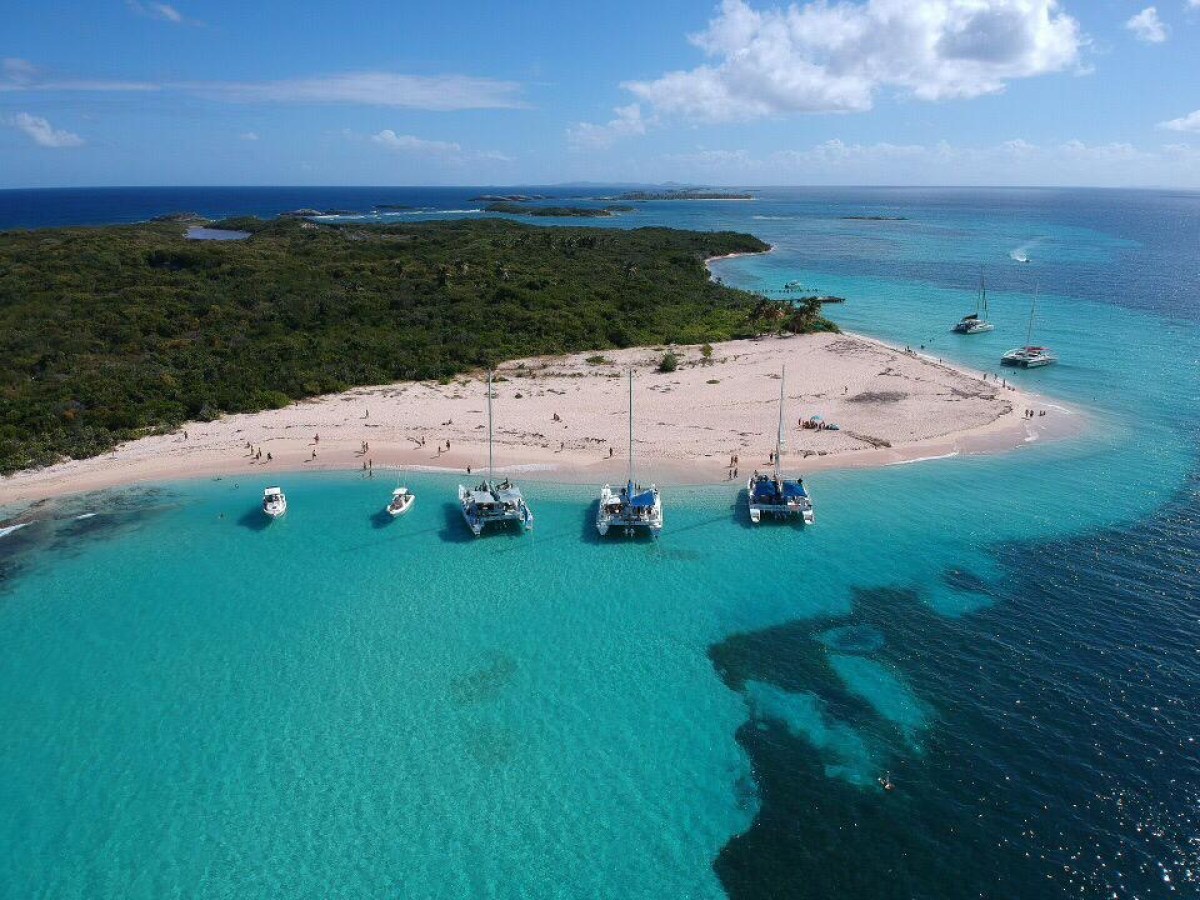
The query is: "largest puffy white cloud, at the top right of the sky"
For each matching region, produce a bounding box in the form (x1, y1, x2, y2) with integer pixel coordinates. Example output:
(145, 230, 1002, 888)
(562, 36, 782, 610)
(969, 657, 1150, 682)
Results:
(623, 0, 1086, 122)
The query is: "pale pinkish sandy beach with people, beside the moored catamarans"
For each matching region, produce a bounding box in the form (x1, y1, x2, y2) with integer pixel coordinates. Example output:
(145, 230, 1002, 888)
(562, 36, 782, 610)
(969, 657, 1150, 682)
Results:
(0, 334, 1082, 505)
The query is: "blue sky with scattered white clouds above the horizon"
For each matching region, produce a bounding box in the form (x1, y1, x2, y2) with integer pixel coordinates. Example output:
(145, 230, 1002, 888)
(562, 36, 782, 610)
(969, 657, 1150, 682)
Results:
(0, 0, 1200, 188)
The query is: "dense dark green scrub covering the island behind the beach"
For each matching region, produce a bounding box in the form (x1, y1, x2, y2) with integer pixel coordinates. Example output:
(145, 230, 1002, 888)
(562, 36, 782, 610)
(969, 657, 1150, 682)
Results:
(0, 218, 832, 473)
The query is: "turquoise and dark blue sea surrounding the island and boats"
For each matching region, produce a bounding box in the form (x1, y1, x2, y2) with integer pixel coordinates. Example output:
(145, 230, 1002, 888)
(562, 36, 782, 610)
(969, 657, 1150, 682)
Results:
(0, 187, 1200, 898)
